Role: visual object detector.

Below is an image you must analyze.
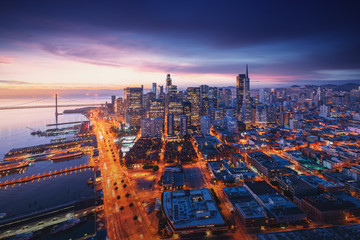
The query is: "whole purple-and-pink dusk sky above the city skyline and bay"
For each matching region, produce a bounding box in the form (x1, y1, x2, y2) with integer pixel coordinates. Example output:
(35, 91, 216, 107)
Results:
(0, 0, 360, 95)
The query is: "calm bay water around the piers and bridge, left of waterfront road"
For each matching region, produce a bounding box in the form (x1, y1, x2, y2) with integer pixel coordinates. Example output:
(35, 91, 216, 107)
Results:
(0, 98, 110, 239)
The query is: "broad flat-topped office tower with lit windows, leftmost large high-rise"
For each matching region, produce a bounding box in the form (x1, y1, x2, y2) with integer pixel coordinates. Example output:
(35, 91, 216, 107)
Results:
(124, 85, 144, 127)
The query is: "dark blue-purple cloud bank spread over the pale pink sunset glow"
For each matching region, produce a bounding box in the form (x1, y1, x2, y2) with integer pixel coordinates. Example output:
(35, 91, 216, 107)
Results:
(0, 0, 360, 82)
